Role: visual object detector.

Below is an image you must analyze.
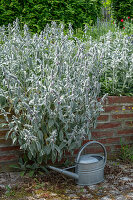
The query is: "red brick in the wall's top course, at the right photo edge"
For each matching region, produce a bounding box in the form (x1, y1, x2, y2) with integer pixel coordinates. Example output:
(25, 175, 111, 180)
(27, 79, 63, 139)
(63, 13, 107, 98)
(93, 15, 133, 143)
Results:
(108, 96, 133, 104)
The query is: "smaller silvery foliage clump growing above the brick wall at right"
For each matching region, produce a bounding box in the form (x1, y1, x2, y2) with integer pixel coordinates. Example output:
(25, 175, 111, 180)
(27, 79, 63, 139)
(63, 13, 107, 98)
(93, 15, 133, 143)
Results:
(86, 30, 133, 96)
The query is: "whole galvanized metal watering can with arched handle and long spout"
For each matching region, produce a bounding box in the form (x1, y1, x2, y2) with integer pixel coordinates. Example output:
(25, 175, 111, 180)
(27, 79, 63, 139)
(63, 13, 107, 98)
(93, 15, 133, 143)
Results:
(48, 141, 107, 185)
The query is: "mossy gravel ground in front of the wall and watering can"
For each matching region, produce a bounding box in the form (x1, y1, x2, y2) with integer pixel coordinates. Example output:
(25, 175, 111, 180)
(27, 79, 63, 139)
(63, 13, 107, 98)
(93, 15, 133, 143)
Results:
(0, 161, 133, 200)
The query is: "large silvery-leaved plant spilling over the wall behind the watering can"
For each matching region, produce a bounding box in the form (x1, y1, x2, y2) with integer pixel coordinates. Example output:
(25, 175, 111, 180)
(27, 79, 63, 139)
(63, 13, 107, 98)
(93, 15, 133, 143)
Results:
(0, 21, 106, 163)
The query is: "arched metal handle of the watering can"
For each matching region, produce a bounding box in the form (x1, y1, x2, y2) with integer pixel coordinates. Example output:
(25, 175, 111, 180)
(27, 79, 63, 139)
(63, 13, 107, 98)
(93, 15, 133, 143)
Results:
(76, 141, 107, 164)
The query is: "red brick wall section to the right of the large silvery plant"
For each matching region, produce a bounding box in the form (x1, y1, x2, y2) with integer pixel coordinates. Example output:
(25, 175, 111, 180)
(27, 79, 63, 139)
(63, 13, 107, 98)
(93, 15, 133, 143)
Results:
(92, 96, 133, 154)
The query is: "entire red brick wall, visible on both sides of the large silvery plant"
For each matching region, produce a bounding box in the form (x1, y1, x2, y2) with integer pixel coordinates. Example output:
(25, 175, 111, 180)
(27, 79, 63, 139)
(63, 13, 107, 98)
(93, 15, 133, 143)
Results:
(0, 97, 133, 171)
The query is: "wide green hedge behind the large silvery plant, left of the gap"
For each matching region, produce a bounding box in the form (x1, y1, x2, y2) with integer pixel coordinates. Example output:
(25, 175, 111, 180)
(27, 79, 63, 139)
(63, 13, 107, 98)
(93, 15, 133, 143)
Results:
(0, 0, 102, 32)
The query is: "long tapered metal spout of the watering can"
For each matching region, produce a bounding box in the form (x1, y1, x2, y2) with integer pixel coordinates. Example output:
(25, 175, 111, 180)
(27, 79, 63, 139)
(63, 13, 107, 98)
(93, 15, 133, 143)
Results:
(48, 166, 79, 180)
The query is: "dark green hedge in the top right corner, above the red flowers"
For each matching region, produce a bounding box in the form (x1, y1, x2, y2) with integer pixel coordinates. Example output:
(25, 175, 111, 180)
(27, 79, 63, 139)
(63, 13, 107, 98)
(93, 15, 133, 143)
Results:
(112, 0, 133, 23)
